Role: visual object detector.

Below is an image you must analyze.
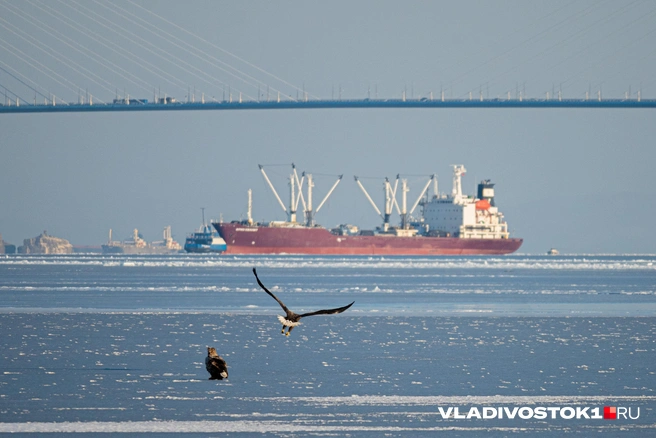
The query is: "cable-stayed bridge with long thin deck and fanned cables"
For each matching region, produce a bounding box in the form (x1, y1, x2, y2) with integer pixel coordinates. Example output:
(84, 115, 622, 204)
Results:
(0, 0, 656, 114)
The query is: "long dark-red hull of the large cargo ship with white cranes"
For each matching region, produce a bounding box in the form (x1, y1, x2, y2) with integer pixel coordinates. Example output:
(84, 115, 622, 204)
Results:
(212, 223, 523, 256)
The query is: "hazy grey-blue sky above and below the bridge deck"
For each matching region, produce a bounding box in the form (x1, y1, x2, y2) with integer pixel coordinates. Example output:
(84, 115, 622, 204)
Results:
(0, 0, 656, 254)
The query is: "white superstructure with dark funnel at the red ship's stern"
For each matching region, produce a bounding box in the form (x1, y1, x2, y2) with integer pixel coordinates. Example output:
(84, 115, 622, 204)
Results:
(422, 165, 509, 239)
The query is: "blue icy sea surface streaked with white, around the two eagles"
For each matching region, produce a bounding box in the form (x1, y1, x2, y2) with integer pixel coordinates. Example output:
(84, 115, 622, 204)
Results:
(0, 254, 656, 437)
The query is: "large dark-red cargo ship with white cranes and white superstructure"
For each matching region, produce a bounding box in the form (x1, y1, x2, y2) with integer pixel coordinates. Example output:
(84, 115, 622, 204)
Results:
(212, 165, 523, 256)
